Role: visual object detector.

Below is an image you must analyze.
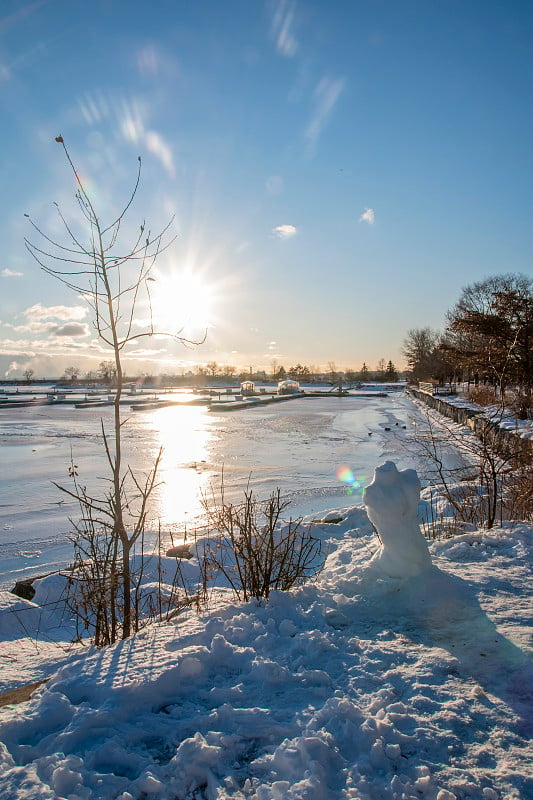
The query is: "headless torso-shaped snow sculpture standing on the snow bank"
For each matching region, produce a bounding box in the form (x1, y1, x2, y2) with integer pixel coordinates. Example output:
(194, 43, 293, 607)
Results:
(363, 461, 431, 578)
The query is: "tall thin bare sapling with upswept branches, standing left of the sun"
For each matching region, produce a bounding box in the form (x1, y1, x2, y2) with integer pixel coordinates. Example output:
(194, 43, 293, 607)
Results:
(25, 136, 205, 638)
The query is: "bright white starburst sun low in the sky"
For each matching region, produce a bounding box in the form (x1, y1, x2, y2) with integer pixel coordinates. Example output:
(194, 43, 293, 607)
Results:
(150, 269, 215, 336)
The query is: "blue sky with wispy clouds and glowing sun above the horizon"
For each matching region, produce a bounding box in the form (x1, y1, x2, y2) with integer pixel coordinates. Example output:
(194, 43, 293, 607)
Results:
(0, 0, 533, 378)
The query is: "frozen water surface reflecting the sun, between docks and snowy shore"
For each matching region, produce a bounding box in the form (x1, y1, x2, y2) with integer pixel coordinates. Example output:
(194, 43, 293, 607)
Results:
(0, 394, 426, 587)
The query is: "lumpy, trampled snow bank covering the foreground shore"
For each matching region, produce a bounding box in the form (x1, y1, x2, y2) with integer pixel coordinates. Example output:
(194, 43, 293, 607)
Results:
(0, 467, 533, 800)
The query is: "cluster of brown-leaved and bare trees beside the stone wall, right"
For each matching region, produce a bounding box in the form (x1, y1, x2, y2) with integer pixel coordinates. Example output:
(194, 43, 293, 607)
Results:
(402, 273, 533, 419)
